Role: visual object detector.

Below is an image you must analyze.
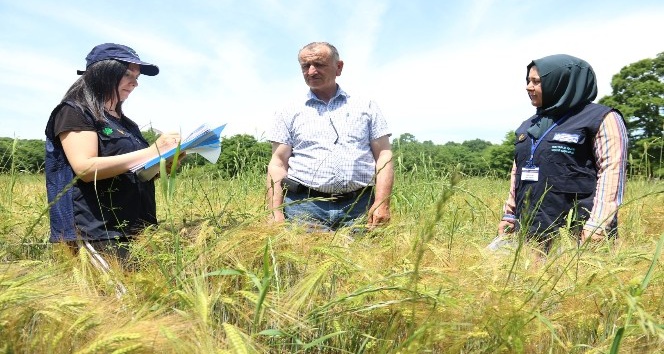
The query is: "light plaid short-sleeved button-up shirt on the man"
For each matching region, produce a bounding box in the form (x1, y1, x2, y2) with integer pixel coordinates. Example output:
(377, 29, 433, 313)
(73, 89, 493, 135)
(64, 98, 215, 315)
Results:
(268, 88, 390, 193)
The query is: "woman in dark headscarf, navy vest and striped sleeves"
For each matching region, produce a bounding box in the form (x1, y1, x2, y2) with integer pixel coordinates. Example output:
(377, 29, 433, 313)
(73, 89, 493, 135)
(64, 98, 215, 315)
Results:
(498, 54, 627, 251)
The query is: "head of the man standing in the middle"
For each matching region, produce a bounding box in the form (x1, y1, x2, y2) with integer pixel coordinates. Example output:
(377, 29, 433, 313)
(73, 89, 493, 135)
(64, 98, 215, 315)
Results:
(298, 46, 344, 92)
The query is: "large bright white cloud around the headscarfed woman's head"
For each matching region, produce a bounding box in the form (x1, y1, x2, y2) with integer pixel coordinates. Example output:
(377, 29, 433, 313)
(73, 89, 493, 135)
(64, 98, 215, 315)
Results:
(342, 7, 664, 143)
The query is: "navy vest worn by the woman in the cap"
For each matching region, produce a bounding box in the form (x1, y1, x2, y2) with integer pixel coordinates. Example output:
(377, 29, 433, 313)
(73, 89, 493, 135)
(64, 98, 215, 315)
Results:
(45, 102, 157, 242)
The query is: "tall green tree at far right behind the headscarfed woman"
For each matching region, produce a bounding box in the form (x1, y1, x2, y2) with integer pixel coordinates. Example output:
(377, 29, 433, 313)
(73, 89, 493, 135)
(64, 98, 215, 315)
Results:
(599, 52, 664, 143)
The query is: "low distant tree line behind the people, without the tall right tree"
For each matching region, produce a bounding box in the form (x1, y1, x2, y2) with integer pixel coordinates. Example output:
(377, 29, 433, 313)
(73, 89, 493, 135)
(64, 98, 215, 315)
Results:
(0, 131, 514, 178)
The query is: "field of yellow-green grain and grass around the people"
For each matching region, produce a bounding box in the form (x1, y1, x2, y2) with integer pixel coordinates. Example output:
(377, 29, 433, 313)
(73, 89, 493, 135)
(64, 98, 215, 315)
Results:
(0, 170, 664, 353)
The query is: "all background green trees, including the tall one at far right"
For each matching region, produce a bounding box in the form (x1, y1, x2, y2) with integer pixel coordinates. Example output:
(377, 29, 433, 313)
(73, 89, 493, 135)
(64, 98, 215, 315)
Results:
(0, 52, 664, 178)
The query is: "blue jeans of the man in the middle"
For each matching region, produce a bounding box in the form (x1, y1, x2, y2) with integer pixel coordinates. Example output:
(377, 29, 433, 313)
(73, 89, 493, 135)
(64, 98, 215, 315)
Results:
(284, 191, 373, 231)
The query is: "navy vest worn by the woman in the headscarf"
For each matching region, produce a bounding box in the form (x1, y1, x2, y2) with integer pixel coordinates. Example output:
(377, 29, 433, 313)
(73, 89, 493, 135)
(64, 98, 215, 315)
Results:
(514, 103, 612, 240)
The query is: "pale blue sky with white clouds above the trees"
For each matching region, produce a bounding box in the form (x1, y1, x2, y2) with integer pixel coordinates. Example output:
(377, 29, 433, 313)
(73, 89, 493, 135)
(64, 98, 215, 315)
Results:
(0, 0, 664, 144)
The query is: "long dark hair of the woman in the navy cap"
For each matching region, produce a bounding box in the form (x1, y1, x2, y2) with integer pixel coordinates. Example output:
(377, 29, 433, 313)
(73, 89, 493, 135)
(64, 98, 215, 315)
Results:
(62, 59, 129, 121)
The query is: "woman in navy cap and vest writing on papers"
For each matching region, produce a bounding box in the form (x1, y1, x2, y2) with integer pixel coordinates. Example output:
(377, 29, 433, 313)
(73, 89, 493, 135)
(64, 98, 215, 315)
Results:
(45, 43, 180, 268)
